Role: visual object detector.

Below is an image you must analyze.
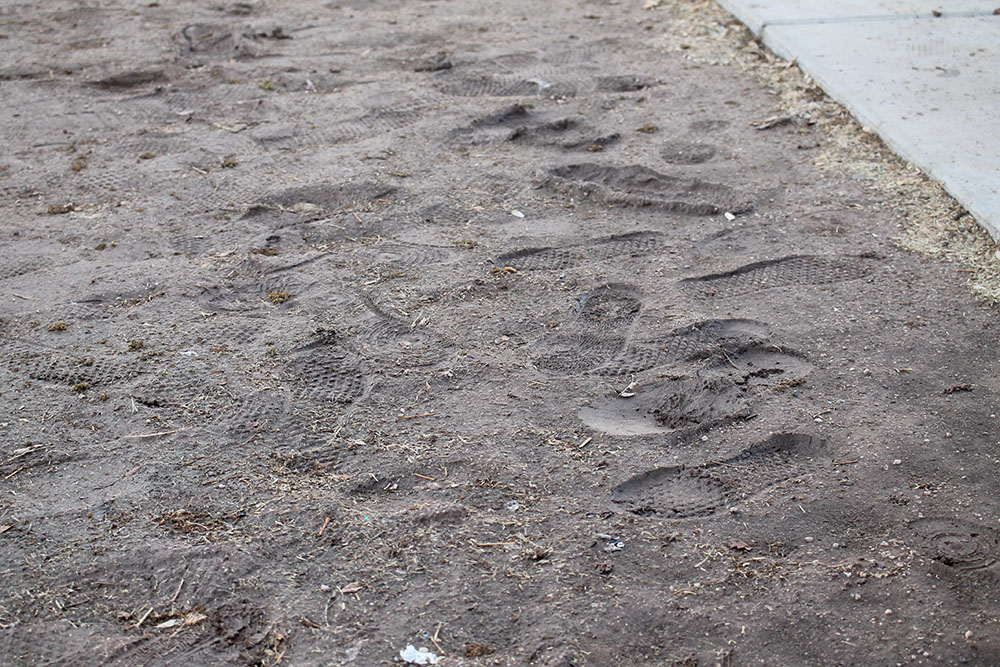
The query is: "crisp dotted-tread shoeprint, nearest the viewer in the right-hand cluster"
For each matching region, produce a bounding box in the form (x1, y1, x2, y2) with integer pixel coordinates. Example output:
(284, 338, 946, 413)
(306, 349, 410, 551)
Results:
(611, 433, 831, 519)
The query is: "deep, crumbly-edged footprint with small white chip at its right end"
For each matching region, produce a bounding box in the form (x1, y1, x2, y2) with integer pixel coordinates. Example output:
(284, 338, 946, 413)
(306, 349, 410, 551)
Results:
(542, 163, 753, 215)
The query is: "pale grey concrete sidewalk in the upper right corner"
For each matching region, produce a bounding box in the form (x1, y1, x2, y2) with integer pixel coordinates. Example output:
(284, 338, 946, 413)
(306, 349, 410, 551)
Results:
(719, 0, 1000, 239)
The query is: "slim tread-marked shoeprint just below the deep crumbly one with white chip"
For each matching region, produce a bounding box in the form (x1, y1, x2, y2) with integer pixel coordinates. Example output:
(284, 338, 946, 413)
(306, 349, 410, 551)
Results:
(494, 232, 667, 271)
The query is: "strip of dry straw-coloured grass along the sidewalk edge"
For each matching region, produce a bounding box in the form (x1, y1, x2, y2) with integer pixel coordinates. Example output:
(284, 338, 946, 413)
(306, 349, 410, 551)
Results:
(654, 0, 1000, 304)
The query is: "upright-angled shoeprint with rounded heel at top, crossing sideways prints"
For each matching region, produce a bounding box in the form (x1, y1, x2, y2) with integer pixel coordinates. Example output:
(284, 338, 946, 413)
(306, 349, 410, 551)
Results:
(535, 283, 642, 375)
